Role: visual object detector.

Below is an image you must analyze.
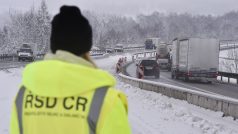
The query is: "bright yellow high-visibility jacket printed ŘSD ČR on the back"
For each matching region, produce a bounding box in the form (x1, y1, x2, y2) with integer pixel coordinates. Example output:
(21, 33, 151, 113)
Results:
(10, 60, 131, 134)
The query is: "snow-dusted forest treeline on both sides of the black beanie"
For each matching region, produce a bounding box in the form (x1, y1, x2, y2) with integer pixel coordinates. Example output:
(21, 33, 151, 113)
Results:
(0, 0, 238, 53)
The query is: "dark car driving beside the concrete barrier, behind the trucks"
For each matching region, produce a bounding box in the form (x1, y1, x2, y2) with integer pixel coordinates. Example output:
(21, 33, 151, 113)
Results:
(136, 59, 160, 78)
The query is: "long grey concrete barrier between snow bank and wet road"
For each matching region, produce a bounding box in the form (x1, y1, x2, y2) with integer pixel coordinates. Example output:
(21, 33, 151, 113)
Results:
(119, 51, 238, 119)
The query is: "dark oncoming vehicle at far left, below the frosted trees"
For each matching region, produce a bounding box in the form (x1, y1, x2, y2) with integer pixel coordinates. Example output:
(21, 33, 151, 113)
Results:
(17, 44, 34, 61)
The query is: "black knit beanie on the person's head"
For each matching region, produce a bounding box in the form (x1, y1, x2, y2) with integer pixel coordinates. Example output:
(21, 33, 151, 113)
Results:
(50, 6, 92, 56)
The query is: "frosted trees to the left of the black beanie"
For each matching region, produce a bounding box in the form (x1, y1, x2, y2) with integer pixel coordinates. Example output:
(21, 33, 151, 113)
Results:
(0, 0, 51, 53)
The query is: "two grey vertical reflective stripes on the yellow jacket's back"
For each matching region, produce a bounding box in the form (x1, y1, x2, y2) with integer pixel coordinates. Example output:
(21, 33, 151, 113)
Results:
(16, 86, 108, 134)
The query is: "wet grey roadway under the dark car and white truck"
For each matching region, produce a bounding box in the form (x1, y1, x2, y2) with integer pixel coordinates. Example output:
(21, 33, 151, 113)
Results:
(126, 63, 238, 99)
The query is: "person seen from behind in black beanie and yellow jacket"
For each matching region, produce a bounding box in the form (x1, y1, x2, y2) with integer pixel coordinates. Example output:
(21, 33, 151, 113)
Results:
(10, 6, 131, 134)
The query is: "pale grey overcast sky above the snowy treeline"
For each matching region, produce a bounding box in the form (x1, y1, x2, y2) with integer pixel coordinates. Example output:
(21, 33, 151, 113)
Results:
(0, 0, 238, 15)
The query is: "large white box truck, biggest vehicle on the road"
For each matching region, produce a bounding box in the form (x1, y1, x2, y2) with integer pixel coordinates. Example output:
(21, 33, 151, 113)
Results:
(171, 38, 219, 83)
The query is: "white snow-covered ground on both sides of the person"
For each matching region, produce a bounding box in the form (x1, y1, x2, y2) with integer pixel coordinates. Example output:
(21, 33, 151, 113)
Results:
(0, 54, 238, 134)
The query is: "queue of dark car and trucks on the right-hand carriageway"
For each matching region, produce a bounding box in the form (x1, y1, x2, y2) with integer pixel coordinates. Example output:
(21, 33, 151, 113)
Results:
(136, 38, 219, 83)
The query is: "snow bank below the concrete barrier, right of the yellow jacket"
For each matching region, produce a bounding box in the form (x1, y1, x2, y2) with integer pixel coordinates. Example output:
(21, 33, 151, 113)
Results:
(117, 82, 238, 134)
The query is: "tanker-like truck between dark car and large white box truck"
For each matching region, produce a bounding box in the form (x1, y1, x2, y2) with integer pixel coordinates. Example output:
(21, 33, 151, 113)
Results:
(156, 42, 171, 71)
